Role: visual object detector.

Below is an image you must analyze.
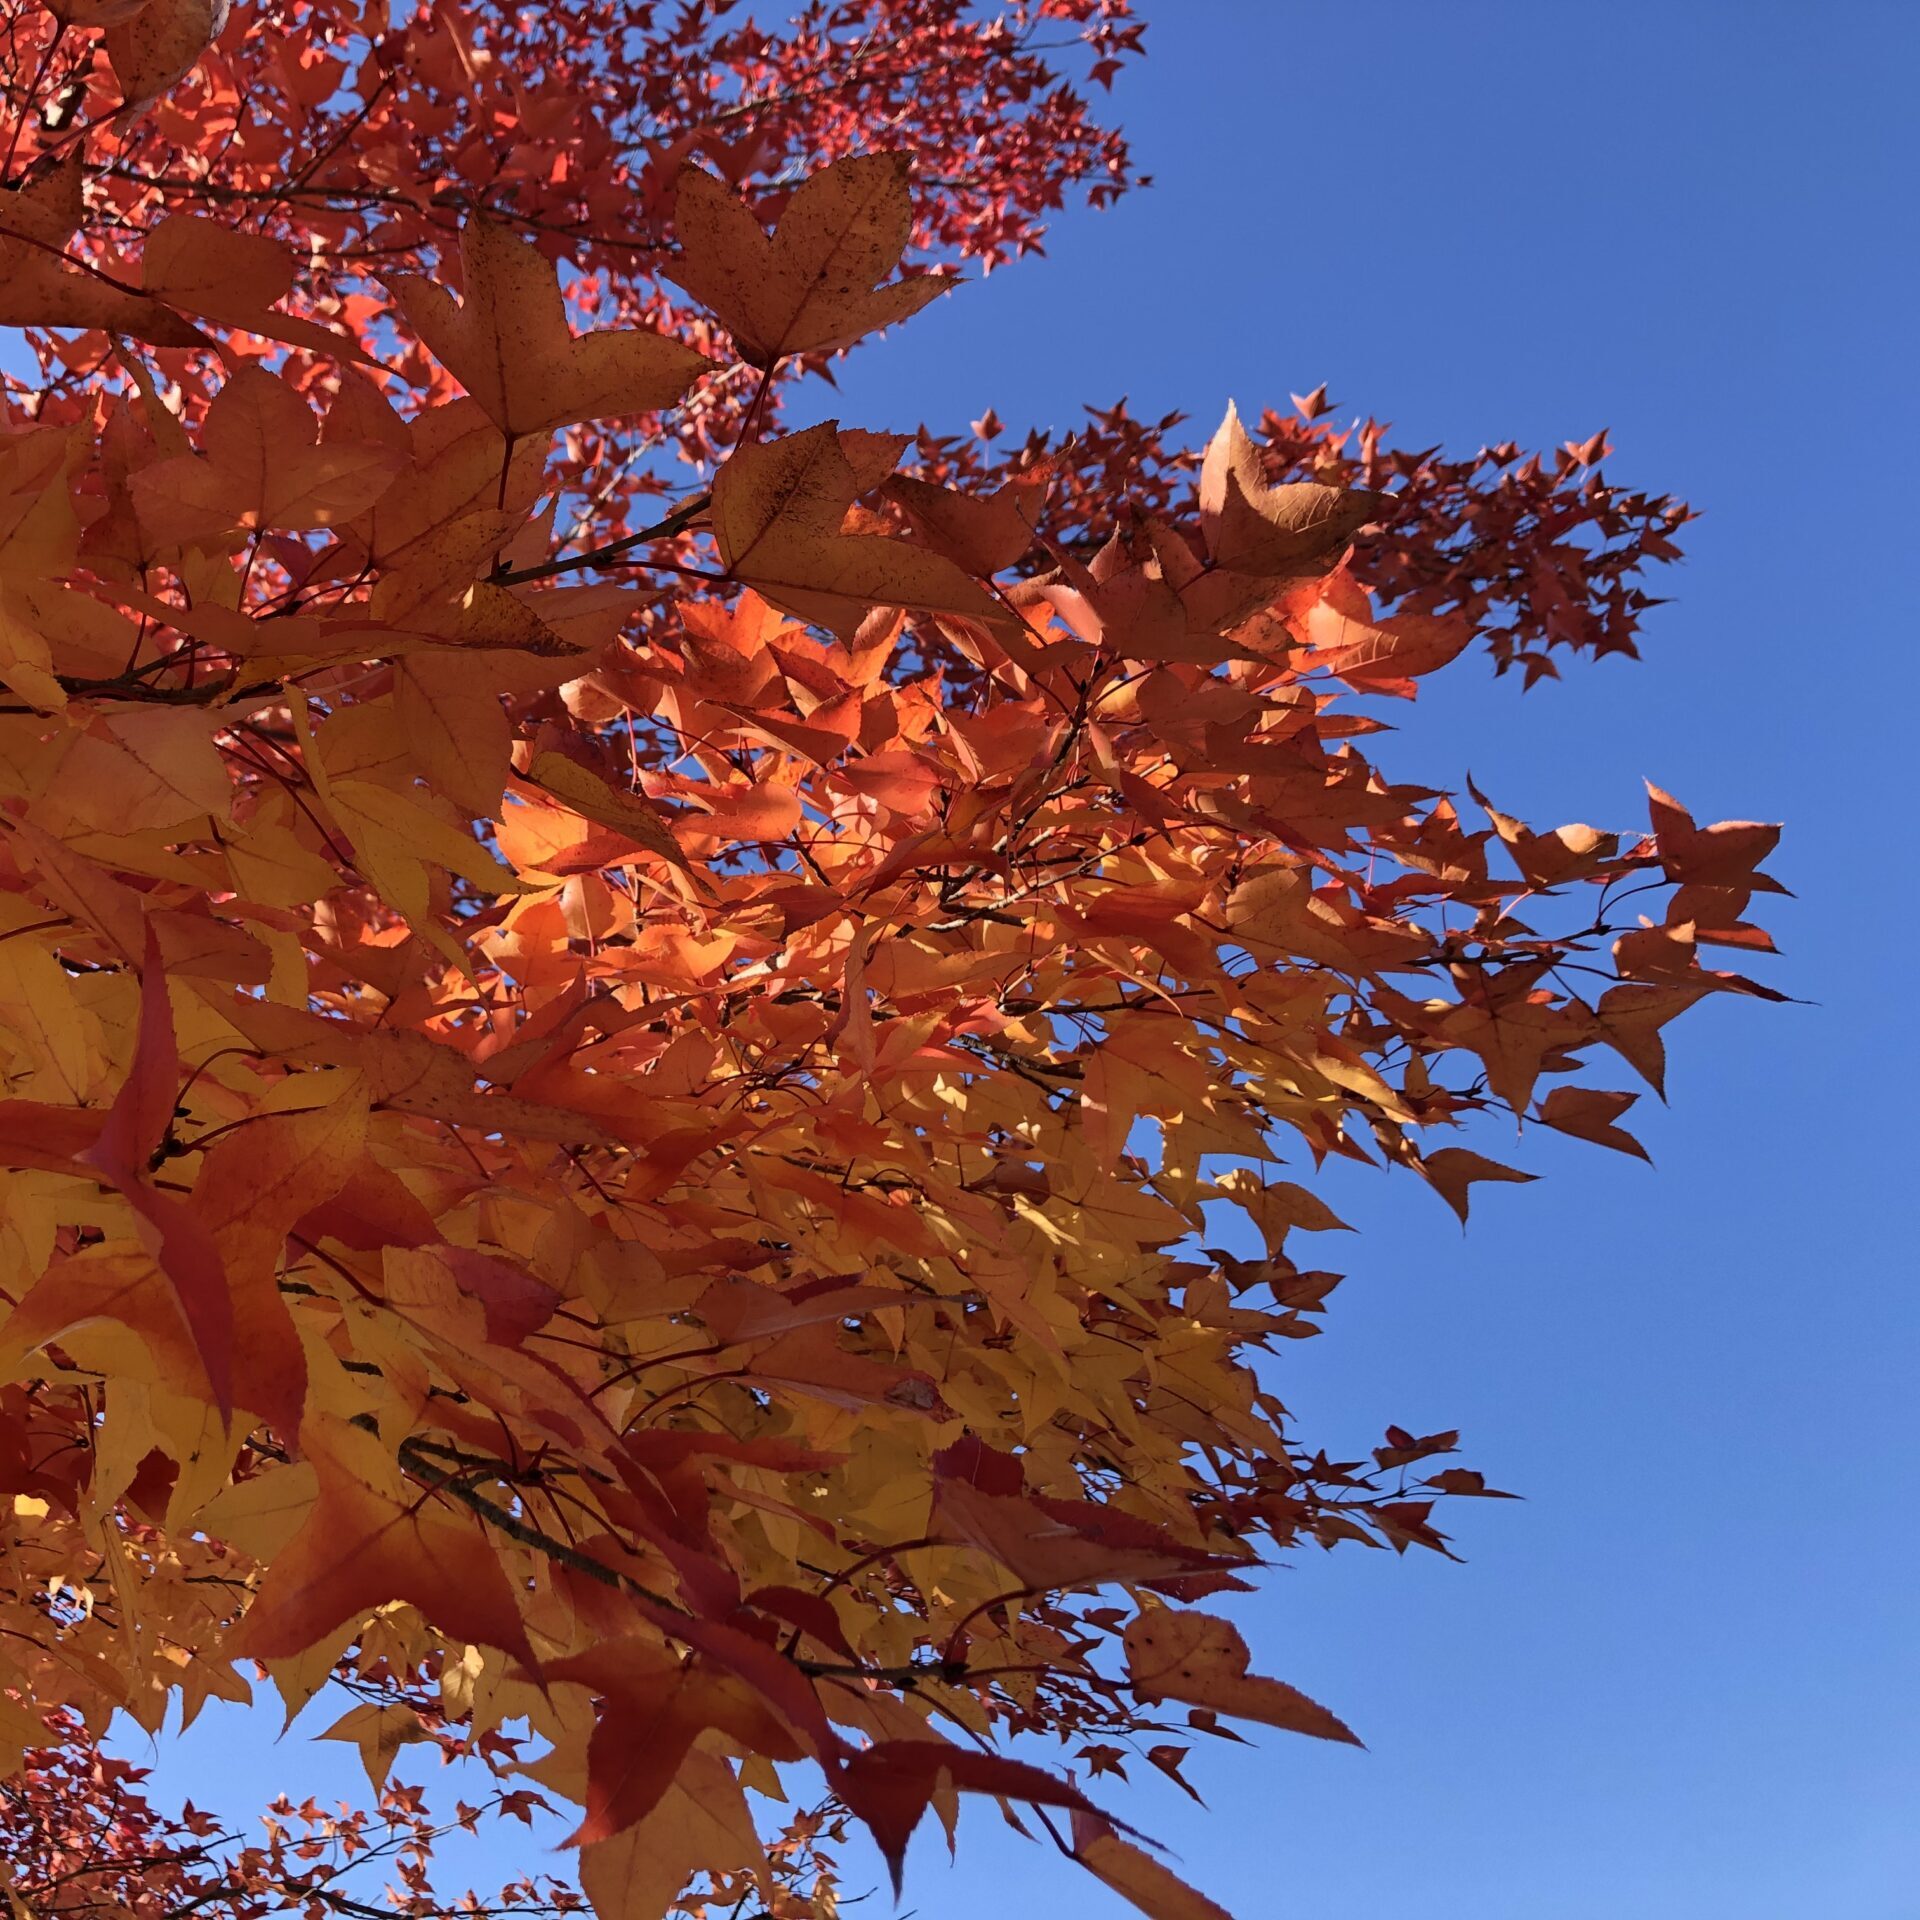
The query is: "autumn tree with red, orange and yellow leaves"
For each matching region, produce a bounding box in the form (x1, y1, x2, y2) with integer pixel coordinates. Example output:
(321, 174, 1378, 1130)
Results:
(0, 0, 1776, 1920)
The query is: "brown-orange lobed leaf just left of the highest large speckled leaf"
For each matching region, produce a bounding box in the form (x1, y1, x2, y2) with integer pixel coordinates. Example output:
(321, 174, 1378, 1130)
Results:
(388, 213, 712, 440)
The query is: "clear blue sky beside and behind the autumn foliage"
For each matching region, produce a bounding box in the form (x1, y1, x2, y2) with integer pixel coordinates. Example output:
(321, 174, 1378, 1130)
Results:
(139, 0, 1920, 1920)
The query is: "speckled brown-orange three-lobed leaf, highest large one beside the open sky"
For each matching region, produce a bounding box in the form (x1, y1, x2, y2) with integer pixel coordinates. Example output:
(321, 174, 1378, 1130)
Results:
(668, 154, 952, 367)
